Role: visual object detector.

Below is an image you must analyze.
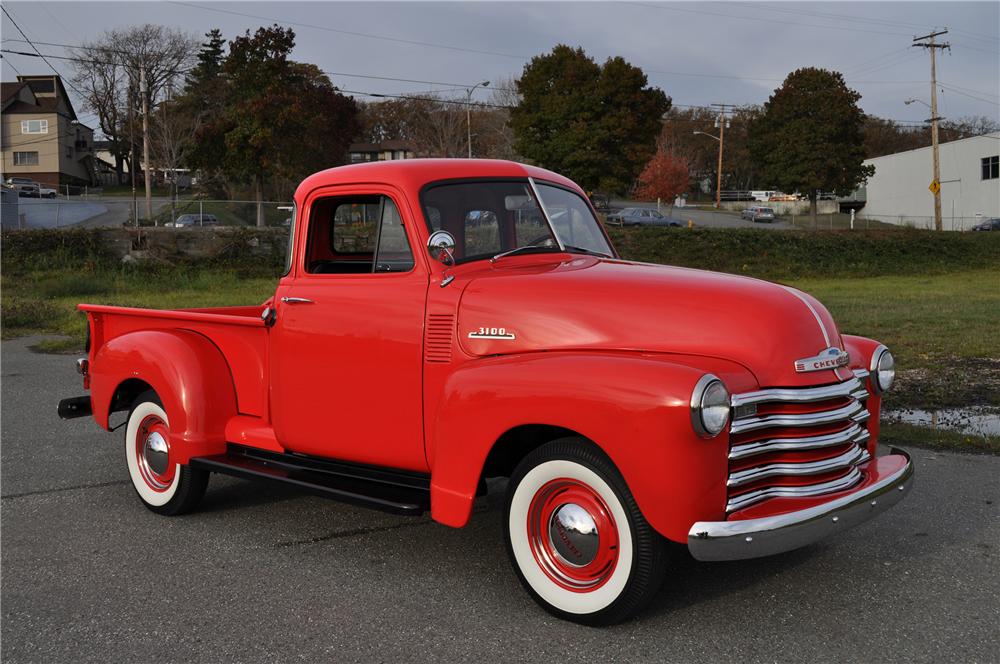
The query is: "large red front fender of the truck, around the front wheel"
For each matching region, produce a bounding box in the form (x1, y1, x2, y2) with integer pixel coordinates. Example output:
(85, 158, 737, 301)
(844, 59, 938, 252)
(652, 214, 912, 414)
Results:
(428, 352, 748, 542)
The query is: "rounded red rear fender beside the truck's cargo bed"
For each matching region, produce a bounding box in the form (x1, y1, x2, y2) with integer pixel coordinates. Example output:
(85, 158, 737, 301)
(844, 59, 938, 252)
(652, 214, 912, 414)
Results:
(90, 330, 237, 464)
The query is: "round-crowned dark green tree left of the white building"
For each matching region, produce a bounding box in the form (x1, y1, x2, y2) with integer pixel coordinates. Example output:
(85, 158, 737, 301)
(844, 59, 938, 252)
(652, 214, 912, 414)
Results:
(749, 68, 875, 222)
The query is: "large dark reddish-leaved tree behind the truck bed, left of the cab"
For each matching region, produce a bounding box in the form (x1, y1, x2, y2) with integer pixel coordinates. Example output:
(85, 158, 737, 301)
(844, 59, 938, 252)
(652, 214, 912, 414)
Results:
(191, 25, 359, 226)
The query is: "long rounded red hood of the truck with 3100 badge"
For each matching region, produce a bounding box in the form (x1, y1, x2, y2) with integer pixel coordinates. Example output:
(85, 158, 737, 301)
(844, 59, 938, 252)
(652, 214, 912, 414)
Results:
(458, 257, 858, 386)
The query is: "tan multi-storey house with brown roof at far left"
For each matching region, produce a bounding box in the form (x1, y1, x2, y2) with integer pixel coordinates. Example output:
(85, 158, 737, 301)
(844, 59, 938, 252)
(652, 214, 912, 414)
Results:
(0, 74, 97, 187)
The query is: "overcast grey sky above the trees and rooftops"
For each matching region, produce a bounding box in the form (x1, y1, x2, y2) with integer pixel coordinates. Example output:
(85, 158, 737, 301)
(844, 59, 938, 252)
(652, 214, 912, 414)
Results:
(2, 0, 1000, 132)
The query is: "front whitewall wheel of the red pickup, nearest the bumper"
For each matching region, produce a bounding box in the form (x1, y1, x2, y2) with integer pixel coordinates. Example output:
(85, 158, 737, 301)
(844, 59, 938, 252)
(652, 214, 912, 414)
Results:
(504, 438, 666, 625)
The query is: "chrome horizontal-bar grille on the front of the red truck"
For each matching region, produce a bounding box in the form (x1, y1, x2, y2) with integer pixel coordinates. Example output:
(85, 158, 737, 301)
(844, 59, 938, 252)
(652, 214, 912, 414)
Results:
(726, 369, 871, 512)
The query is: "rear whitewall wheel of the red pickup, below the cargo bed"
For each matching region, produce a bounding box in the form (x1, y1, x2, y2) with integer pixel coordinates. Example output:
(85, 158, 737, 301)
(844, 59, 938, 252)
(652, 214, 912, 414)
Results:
(125, 390, 208, 516)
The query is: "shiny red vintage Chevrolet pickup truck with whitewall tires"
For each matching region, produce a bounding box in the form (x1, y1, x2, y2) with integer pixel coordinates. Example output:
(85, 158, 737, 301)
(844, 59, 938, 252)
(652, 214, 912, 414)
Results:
(59, 160, 913, 624)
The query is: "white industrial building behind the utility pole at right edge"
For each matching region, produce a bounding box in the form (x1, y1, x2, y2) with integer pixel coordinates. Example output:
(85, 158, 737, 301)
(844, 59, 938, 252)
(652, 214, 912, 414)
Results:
(859, 132, 1000, 230)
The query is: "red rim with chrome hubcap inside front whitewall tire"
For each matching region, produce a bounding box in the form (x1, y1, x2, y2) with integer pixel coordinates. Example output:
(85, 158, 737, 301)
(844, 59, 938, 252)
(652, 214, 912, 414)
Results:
(527, 478, 618, 593)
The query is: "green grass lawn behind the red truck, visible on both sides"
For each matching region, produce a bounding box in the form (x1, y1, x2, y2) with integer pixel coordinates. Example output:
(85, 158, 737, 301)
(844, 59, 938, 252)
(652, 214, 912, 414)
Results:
(0, 227, 1000, 454)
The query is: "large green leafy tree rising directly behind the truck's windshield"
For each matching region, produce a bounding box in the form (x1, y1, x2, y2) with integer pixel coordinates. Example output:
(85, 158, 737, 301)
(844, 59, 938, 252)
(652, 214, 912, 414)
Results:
(511, 44, 670, 192)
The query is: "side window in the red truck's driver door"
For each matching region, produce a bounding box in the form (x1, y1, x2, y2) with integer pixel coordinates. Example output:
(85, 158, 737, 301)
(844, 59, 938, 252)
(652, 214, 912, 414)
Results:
(305, 195, 413, 274)
